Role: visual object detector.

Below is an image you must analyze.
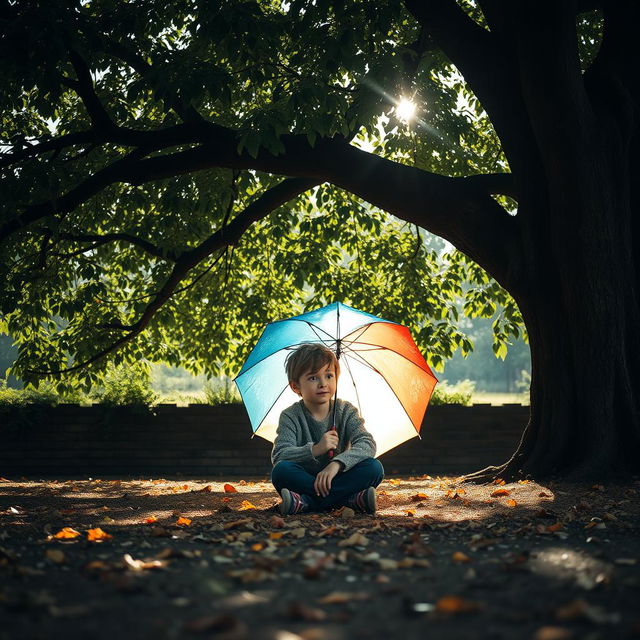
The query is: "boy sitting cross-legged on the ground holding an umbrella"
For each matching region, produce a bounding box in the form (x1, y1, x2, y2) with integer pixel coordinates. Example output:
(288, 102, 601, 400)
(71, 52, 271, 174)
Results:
(271, 344, 384, 515)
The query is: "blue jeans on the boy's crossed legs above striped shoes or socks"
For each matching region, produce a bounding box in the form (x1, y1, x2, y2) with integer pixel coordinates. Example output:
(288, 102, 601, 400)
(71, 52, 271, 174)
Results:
(271, 458, 384, 511)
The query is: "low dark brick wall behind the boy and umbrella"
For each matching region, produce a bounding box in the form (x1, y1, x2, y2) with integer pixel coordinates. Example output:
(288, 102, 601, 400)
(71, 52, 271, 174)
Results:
(0, 405, 529, 477)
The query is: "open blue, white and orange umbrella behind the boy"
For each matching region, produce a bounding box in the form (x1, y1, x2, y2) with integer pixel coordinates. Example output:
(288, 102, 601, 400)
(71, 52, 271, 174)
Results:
(235, 302, 437, 455)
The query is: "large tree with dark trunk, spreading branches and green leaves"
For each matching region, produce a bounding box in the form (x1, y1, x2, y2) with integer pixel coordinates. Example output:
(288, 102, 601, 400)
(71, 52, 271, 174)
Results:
(0, 0, 640, 477)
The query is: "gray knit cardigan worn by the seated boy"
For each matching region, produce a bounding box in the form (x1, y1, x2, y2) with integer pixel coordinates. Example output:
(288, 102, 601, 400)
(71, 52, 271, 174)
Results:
(271, 399, 376, 474)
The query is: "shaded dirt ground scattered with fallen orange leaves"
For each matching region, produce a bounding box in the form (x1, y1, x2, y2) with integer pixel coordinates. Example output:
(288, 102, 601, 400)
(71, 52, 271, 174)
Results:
(0, 476, 640, 640)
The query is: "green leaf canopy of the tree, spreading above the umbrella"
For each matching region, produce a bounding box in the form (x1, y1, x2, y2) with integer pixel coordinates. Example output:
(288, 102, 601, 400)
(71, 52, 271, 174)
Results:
(0, 0, 556, 387)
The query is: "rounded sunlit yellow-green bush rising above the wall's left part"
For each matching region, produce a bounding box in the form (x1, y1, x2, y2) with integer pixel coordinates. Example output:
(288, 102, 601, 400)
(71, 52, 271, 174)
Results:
(96, 364, 158, 408)
